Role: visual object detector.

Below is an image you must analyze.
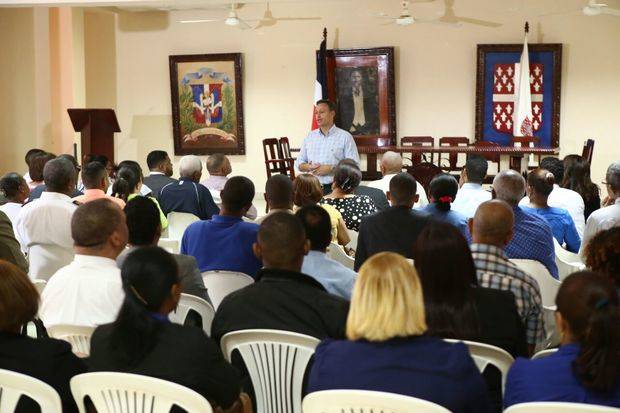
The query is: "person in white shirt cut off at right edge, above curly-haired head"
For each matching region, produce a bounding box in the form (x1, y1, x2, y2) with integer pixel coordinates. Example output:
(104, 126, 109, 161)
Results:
(581, 161, 620, 254)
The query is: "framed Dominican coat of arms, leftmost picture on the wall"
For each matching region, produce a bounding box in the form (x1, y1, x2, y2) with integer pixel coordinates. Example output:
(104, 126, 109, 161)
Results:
(169, 53, 245, 155)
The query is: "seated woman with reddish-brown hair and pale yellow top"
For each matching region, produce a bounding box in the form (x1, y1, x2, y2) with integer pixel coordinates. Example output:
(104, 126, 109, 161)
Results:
(293, 174, 351, 245)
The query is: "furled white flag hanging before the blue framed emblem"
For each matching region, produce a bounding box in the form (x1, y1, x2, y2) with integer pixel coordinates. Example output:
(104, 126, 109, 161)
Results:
(512, 31, 534, 136)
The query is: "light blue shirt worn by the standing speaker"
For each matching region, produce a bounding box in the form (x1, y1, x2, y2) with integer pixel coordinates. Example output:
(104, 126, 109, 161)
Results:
(295, 125, 360, 185)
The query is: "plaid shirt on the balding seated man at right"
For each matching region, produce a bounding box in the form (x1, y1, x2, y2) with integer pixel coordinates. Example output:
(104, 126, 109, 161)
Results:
(471, 244, 545, 344)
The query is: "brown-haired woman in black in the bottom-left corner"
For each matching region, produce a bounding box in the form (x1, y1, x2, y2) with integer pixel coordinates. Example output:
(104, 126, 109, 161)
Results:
(0, 261, 86, 413)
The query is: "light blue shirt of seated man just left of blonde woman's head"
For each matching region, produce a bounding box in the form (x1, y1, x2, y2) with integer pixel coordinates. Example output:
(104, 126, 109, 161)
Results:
(301, 251, 357, 300)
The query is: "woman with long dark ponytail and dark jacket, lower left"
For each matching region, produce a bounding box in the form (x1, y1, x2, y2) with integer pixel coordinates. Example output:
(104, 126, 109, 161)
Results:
(89, 247, 241, 408)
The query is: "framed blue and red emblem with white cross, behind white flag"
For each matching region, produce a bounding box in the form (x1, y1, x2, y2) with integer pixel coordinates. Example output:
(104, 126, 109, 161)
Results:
(476, 43, 562, 148)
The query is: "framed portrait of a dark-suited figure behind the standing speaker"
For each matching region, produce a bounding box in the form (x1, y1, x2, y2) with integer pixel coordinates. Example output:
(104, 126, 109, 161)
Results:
(326, 47, 396, 146)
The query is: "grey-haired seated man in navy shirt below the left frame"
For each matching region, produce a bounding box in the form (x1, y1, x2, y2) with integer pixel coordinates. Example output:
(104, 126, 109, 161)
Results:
(158, 155, 219, 219)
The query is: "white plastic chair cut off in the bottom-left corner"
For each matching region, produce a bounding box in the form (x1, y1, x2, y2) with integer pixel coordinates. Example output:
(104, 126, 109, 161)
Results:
(0, 369, 62, 413)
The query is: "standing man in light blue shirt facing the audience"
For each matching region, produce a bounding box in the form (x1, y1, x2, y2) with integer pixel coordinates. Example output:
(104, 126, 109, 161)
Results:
(295, 100, 360, 194)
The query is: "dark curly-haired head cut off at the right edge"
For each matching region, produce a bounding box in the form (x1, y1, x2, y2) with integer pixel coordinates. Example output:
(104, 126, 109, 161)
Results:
(585, 226, 620, 295)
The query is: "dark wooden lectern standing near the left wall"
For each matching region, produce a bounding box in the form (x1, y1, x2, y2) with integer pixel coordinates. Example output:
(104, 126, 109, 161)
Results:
(67, 109, 121, 162)
